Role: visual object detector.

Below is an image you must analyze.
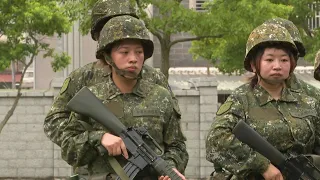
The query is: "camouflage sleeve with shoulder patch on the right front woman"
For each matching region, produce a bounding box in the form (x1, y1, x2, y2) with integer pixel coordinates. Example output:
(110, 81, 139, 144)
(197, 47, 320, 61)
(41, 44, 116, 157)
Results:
(206, 95, 269, 178)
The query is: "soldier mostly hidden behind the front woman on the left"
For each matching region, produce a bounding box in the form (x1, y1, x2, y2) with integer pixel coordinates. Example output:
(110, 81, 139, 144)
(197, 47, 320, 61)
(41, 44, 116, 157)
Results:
(44, 0, 180, 149)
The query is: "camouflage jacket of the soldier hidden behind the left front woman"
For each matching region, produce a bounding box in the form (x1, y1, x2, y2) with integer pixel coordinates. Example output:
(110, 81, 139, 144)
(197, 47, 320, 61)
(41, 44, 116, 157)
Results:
(44, 60, 180, 146)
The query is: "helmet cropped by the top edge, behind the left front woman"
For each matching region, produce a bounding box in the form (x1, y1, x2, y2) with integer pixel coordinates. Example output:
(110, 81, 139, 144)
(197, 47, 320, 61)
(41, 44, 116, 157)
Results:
(91, 0, 138, 41)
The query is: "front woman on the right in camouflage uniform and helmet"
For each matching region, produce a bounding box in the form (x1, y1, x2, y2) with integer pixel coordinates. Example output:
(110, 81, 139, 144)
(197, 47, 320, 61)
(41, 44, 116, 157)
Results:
(206, 24, 320, 180)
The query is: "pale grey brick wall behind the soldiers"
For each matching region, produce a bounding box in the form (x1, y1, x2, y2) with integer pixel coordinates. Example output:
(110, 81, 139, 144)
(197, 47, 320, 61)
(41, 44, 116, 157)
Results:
(0, 79, 217, 179)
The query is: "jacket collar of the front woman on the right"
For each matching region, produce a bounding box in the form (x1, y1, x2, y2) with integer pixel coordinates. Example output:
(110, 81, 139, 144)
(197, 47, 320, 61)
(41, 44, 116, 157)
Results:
(253, 85, 298, 106)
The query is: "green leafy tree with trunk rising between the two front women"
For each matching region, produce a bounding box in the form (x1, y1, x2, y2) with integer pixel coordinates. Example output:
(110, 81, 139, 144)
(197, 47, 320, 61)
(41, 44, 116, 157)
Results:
(65, 0, 319, 76)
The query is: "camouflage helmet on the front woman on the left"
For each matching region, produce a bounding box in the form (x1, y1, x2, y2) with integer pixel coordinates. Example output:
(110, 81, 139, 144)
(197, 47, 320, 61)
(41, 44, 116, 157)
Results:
(96, 15, 154, 59)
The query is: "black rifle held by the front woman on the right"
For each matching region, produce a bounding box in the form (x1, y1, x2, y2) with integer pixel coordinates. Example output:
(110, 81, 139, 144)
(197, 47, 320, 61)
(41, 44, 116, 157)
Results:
(232, 121, 320, 180)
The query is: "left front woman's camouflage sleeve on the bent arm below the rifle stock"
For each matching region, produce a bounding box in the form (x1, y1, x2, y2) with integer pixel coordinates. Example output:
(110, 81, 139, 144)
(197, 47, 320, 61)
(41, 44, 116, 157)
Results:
(61, 113, 105, 166)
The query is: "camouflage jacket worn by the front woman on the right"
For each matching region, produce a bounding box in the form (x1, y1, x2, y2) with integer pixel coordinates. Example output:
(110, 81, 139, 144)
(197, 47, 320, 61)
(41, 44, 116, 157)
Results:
(206, 84, 320, 179)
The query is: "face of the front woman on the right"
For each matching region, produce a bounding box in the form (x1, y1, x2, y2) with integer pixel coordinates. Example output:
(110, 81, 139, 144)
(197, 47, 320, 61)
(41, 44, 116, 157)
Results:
(252, 48, 291, 84)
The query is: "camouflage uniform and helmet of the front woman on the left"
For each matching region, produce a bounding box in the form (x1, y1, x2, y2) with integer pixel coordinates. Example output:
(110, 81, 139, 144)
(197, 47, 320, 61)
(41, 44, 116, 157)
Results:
(60, 15, 189, 180)
